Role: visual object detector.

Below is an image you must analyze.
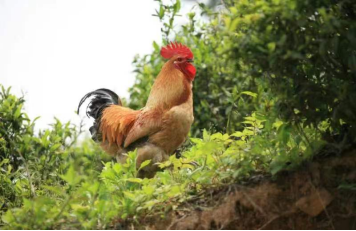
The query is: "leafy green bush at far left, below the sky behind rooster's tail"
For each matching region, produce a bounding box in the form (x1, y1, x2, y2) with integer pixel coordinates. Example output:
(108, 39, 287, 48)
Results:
(0, 85, 110, 228)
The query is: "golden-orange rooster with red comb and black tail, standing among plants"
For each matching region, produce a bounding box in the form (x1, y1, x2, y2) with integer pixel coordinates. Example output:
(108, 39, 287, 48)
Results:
(78, 42, 196, 178)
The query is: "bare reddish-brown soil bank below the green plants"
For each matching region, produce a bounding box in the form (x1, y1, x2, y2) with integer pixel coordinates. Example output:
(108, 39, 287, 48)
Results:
(120, 151, 356, 230)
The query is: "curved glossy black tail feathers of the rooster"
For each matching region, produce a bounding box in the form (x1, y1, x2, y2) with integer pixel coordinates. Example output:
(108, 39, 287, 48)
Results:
(78, 89, 122, 141)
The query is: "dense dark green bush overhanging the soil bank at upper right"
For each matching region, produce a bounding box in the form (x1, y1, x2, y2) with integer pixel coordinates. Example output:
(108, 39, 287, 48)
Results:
(223, 0, 356, 135)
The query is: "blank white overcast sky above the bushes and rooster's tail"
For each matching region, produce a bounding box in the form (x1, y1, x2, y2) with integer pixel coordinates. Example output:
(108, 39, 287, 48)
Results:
(0, 0, 200, 134)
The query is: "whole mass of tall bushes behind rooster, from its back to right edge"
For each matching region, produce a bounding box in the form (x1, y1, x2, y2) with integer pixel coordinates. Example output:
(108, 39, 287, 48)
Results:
(130, 0, 356, 137)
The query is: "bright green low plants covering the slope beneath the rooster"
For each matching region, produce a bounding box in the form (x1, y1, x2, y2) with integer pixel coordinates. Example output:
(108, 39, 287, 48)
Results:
(0, 84, 326, 229)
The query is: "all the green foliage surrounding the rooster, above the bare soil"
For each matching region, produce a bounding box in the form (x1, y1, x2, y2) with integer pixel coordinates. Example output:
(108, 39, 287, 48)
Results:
(0, 0, 356, 229)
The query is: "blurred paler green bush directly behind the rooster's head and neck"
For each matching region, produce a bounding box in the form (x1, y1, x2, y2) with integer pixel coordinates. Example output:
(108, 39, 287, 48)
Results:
(130, 1, 256, 136)
